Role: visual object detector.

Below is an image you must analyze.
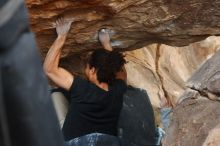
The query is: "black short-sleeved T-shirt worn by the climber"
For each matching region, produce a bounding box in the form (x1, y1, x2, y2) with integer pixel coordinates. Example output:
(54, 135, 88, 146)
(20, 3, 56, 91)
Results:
(63, 77, 127, 141)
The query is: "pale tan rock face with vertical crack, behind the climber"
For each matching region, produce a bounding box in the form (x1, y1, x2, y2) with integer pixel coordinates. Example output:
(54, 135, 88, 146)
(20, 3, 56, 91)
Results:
(126, 37, 220, 107)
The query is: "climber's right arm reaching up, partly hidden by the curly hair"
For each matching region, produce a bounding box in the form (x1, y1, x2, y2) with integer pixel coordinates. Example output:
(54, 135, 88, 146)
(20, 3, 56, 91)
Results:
(99, 29, 127, 81)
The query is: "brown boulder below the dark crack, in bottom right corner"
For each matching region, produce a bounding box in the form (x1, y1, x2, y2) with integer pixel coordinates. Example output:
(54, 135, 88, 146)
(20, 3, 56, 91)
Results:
(164, 97, 220, 146)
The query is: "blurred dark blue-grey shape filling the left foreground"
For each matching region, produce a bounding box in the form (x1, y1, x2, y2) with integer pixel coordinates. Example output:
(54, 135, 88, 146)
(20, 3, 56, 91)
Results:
(0, 0, 64, 146)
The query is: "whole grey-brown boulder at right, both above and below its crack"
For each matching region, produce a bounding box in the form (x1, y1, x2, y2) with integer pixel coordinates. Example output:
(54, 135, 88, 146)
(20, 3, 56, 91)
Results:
(164, 51, 220, 146)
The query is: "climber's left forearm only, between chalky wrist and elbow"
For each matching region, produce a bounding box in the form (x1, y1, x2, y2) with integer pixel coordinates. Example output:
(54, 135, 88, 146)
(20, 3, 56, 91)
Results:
(44, 35, 66, 72)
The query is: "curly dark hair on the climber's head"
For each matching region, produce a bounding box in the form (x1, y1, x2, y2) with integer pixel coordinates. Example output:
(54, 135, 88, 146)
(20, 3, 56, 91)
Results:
(87, 49, 126, 84)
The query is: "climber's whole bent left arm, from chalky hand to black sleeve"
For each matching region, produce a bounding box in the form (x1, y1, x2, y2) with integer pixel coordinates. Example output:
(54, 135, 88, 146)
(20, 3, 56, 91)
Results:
(43, 19, 74, 90)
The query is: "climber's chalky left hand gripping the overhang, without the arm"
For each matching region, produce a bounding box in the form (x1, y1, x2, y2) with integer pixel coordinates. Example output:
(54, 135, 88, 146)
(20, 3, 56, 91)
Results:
(56, 18, 72, 36)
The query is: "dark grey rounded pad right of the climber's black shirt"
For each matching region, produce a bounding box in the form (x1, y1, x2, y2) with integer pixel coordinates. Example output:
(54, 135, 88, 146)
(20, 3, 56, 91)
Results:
(119, 86, 156, 146)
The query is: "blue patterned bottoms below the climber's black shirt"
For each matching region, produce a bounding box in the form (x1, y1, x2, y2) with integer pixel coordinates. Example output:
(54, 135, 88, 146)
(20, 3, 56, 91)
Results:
(66, 133, 120, 146)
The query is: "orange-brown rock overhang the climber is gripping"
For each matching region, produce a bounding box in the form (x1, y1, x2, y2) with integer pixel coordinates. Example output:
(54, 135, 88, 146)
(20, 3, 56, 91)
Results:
(26, 0, 220, 55)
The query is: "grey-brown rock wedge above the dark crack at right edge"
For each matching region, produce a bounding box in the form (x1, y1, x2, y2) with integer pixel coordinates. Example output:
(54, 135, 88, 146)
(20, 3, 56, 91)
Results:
(187, 51, 220, 100)
